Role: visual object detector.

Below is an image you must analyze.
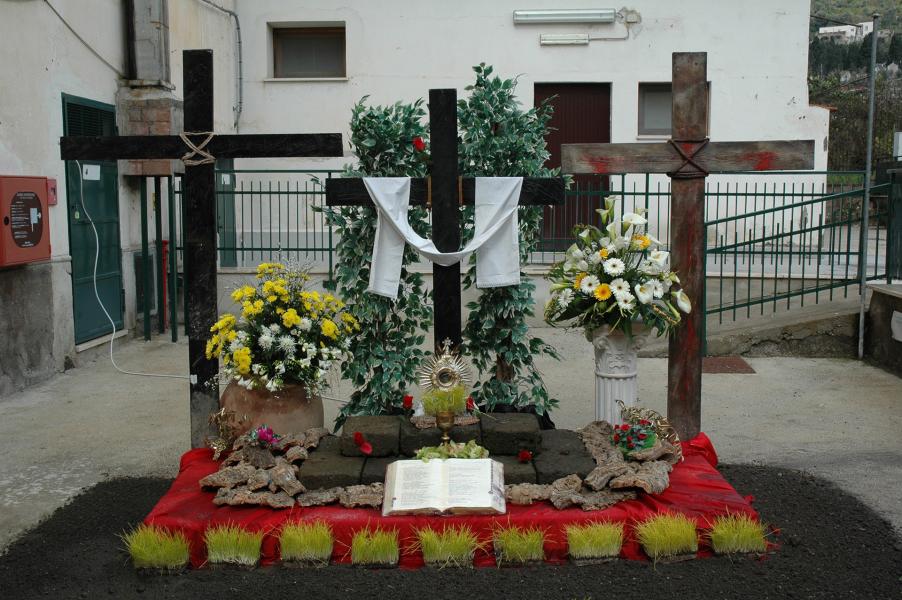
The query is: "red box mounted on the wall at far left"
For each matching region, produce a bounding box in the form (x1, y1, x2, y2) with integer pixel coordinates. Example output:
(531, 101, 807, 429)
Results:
(0, 175, 56, 267)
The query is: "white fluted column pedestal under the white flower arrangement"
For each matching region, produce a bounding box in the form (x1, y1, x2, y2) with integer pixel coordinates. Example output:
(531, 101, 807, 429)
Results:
(586, 323, 650, 423)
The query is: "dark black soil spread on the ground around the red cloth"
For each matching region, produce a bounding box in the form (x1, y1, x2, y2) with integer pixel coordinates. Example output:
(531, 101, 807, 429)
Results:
(0, 466, 902, 600)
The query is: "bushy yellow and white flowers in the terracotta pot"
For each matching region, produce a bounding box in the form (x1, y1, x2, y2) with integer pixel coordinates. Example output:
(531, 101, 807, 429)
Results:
(206, 263, 360, 393)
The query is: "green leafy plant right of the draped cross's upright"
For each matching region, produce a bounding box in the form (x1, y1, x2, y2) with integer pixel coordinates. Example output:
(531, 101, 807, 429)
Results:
(457, 63, 559, 415)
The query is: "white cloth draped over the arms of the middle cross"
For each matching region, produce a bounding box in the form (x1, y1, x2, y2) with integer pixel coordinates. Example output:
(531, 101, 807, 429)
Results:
(363, 177, 523, 299)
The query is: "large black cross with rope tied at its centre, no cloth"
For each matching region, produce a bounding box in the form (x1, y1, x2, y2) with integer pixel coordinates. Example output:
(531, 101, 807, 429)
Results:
(60, 50, 342, 447)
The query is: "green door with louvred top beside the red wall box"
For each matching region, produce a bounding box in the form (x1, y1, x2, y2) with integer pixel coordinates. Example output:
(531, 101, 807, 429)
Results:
(63, 94, 123, 344)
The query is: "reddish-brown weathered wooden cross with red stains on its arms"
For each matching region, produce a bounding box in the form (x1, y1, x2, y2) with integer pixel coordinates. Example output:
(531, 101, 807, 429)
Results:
(561, 52, 814, 439)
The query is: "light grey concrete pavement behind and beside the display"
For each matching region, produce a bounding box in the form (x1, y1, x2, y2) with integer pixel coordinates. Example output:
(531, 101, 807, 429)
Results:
(0, 328, 902, 547)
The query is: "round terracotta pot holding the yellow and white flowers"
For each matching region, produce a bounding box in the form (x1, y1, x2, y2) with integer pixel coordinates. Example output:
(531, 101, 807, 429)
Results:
(219, 381, 323, 435)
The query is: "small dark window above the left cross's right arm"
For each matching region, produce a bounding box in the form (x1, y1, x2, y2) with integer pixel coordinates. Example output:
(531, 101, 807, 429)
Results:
(272, 24, 347, 79)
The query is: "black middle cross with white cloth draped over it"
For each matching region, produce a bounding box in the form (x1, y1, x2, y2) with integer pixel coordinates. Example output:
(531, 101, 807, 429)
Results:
(326, 89, 564, 351)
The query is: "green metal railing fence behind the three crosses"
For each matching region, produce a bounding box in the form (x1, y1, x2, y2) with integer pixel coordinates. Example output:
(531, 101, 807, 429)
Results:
(150, 169, 900, 340)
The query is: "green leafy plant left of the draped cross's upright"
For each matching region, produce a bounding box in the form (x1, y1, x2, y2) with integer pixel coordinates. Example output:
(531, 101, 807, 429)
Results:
(323, 97, 432, 430)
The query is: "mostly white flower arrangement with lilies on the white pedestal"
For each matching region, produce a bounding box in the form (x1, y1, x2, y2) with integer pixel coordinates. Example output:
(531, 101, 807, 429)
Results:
(545, 197, 692, 335)
